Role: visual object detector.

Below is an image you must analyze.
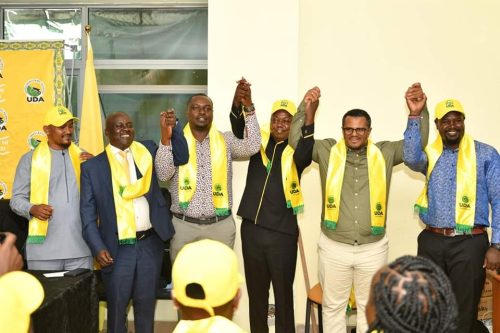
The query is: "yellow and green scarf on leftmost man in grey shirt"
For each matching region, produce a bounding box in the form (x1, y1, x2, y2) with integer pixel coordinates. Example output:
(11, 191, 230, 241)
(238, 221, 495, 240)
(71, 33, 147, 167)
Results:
(27, 141, 81, 244)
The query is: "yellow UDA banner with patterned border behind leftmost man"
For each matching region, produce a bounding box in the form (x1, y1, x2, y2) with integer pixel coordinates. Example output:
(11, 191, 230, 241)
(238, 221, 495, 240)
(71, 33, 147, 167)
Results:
(0, 41, 64, 199)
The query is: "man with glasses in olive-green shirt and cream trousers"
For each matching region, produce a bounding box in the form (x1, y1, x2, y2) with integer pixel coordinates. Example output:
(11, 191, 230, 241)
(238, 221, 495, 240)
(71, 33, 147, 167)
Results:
(289, 83, 429, 333)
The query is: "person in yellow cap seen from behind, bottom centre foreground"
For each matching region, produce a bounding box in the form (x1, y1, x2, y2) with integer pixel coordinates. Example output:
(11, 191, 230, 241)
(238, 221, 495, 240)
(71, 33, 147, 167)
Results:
(172, 239, 244, 333)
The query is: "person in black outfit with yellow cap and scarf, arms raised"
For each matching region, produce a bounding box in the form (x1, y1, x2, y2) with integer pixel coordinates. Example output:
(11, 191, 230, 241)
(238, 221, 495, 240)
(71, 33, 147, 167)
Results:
(230, 87, 314, 333)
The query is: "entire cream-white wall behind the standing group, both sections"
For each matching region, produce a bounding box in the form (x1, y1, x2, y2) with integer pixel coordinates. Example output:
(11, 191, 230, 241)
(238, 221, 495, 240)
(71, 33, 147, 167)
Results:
(208, 0, 500, 329)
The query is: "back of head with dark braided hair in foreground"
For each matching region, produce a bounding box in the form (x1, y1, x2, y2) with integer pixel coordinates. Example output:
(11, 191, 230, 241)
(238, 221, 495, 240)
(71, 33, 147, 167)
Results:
(366, 256, 457, 333)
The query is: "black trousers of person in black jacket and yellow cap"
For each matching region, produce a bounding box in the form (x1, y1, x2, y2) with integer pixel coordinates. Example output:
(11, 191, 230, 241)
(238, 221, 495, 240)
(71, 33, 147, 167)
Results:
(241, 220, 298, 333)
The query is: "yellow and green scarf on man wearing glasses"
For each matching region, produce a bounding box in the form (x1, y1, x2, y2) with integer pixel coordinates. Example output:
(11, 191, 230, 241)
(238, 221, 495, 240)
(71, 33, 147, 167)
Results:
(323, 140, 387, 235)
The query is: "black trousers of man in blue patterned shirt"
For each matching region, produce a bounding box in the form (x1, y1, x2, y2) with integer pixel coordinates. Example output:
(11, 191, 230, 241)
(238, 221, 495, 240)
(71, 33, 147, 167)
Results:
(418, 230, 489, 333)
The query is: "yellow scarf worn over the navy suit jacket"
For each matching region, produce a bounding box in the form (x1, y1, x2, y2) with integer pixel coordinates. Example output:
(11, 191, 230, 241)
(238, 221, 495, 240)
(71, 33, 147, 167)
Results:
(105, 141, 153, 244)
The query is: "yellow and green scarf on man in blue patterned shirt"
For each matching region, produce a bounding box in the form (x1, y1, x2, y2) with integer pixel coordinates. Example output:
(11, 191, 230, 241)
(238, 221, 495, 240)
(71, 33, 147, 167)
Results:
(415, 134, 477, 233)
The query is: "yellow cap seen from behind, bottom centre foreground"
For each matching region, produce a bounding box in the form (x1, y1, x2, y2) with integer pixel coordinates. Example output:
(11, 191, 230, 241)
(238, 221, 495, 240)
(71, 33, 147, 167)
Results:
(172, 239, 243, 316)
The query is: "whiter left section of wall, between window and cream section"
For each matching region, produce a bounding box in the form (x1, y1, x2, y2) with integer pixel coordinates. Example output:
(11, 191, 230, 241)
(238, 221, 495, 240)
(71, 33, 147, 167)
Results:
(208, 0, 298, 330)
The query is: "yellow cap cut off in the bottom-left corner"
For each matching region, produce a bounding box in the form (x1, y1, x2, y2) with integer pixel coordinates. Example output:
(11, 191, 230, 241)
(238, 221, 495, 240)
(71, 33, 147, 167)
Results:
(0, 271, 44, 333)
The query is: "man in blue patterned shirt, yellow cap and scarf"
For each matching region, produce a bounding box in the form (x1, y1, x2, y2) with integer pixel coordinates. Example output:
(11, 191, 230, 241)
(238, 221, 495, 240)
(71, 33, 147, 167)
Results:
(404, 92, 500, 333)
